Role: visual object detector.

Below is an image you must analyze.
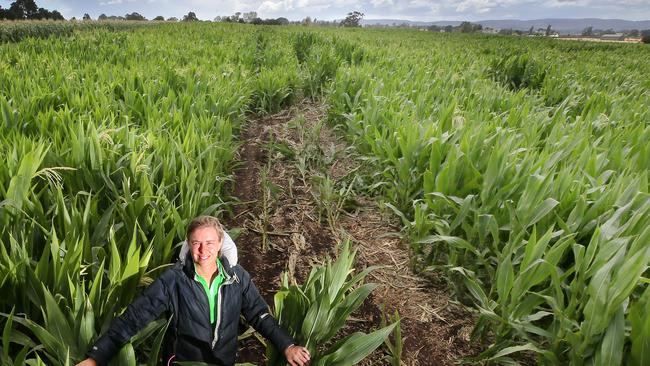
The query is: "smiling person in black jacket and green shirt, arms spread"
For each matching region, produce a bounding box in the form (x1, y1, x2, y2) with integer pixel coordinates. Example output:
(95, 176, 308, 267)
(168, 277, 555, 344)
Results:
(78, 216, 310, 366)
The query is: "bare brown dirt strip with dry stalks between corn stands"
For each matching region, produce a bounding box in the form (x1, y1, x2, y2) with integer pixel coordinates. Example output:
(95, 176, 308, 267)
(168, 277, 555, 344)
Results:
(225, 101, 479, 366)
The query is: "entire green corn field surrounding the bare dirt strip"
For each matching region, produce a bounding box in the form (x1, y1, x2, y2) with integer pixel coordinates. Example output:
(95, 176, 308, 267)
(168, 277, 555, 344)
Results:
(0, 23, 650, 365)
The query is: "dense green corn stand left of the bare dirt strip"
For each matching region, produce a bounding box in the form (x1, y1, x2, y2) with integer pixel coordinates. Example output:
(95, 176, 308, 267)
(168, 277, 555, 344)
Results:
(0, 24, 253, 364)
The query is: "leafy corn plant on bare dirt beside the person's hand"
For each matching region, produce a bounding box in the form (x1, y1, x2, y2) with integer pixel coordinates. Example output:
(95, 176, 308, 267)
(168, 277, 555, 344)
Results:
(267, 241, 396, 365)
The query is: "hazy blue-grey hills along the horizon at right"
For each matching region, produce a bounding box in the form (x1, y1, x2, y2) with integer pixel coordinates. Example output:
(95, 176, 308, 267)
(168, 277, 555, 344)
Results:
(361, 18, 650, 34)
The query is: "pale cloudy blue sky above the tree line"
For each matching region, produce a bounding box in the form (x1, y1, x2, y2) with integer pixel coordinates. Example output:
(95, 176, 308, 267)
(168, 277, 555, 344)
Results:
(0, 0, 650, 21)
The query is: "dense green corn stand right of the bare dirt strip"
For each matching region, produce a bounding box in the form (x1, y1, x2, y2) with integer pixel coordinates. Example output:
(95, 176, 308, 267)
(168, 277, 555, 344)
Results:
(327, 27, 650, 365)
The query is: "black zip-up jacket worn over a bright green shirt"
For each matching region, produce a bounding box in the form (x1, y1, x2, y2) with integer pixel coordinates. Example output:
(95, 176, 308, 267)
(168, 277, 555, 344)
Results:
(88, 253, 295, 365)
